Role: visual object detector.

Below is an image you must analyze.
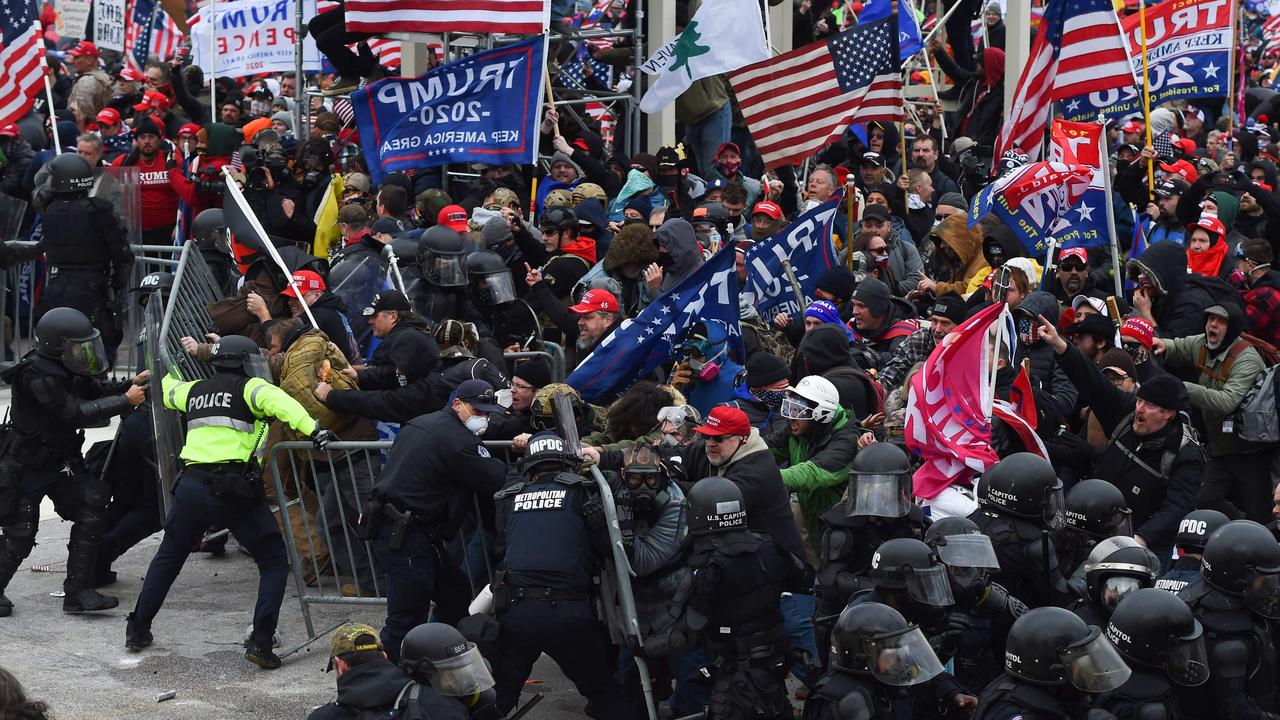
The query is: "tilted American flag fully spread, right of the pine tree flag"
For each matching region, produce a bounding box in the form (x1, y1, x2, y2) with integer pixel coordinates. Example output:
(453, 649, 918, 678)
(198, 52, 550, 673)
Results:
(730, 15, 904, 168)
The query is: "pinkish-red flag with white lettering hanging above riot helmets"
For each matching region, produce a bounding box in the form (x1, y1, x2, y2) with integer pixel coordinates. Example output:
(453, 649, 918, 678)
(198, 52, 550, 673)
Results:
(905, 304, 1012, 500)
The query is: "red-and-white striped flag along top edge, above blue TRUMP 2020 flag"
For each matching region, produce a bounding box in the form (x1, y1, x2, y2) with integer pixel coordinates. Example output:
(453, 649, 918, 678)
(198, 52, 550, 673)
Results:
(347, 0, 550, 35)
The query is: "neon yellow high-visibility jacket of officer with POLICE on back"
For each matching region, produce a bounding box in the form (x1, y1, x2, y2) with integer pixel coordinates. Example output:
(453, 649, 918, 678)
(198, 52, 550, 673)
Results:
(160, 366, 319, 465)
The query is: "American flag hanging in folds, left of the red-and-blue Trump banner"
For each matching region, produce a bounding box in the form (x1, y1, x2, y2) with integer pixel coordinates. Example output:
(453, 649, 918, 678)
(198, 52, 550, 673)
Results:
(996, 0, 1135, 160)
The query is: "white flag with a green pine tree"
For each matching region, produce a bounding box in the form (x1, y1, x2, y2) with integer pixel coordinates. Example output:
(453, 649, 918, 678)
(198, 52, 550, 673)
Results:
(640, 0, 769, 113)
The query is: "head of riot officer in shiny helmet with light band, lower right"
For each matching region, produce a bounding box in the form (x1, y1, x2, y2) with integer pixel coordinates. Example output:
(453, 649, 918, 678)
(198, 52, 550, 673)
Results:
(1070, 537, 1160, 628)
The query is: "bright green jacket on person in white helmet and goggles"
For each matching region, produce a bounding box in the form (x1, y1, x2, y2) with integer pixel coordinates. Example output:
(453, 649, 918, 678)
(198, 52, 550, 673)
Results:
(769, 407, 859, 551)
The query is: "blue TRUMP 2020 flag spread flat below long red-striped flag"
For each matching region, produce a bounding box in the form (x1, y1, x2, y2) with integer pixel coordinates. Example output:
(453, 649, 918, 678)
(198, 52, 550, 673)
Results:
(351, 37, 547, 183)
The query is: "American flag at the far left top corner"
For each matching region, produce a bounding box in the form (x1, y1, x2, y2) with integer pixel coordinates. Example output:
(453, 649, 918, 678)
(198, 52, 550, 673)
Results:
(0, 0, 45, 127)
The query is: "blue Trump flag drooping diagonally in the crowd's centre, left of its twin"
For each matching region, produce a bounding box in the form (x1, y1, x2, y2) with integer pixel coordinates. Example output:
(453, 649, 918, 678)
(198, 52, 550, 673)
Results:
(564, 245, 745, 402)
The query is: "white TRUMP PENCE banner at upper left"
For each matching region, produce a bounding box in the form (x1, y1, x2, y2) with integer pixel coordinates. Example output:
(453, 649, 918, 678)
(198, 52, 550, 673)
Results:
(189, 0, 320, 77)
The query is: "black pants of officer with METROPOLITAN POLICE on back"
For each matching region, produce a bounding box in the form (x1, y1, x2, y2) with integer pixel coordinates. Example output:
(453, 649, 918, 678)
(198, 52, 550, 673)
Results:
(493, 600, 632, 719)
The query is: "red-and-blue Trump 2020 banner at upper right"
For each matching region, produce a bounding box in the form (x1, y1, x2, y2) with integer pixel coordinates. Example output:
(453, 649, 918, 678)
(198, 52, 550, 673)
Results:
(1062, 0, 1234, 120)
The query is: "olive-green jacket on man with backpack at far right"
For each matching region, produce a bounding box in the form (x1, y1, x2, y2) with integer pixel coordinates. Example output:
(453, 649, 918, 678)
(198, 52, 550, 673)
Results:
(1165, 334, 1266, 457)
